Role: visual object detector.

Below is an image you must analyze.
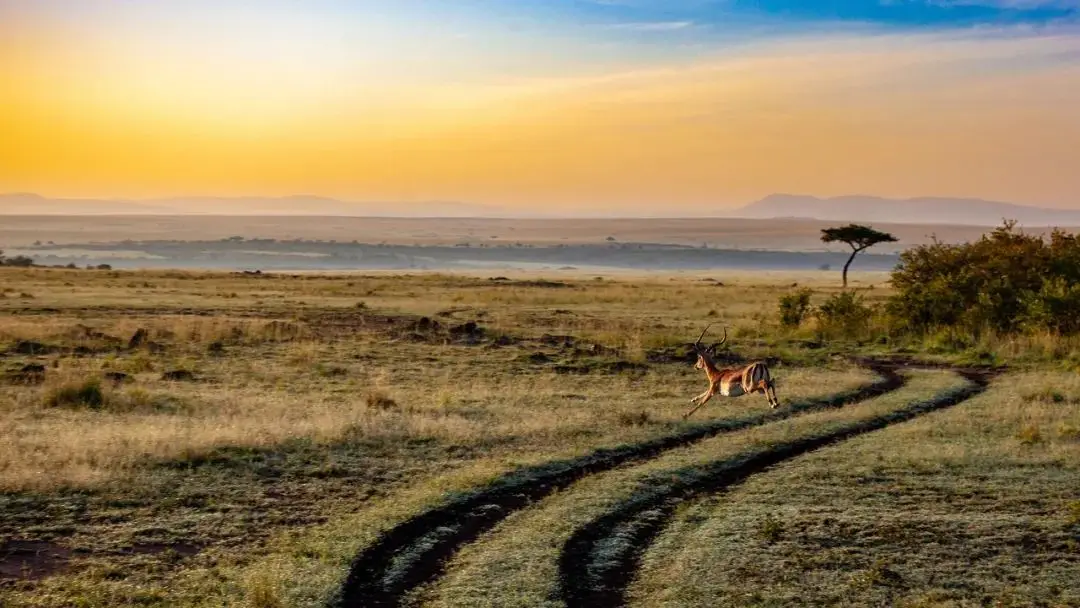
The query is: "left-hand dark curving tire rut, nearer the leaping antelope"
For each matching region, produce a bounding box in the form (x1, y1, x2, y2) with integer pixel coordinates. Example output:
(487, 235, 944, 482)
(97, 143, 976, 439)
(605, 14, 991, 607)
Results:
(329, 361, 907, 608)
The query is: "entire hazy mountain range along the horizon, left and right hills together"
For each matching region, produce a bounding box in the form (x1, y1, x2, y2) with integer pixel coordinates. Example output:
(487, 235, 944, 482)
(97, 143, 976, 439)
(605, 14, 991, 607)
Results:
(6, 193, 1080, 227)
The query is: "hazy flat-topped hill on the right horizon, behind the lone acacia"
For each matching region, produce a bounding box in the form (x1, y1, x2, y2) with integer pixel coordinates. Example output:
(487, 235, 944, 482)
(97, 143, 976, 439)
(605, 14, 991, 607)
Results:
(732, 194, 1080, 226)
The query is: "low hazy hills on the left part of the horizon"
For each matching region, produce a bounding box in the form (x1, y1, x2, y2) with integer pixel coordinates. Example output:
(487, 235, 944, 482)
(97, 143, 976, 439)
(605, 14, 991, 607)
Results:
(0, 193, 500, 217)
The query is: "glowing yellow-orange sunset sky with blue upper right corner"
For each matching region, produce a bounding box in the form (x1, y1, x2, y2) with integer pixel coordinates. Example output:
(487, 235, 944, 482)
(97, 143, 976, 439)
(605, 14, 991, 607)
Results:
(0, 0, 1080, 214)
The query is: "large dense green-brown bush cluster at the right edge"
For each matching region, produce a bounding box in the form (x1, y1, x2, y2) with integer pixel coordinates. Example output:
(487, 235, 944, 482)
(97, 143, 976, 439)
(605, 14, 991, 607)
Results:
(888, 221, 1080, 336)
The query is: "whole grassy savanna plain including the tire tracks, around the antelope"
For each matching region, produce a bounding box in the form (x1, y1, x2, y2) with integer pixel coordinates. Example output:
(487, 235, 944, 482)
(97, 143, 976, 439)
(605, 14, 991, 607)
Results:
(0, 268, 1080, 608)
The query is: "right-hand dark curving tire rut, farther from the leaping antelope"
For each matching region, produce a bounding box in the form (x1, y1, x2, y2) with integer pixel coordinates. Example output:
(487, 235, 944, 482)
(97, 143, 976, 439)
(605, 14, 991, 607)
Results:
(557, 362, 995, 608)
